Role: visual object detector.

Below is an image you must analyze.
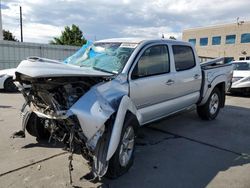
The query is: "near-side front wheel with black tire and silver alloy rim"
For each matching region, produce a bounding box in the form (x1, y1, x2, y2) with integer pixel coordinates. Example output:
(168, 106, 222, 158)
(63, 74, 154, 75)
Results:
(106, 114, 138, 179)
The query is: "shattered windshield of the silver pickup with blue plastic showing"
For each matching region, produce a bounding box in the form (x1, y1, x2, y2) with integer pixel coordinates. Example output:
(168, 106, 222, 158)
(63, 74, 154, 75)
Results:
(64, 43, 136, 74)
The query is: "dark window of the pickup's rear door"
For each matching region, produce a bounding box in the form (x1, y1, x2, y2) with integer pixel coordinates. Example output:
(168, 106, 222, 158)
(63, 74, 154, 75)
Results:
(173, 45, 195, 71)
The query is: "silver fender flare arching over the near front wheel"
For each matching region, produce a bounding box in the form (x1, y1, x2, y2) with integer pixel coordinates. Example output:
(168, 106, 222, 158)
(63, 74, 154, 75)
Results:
(106, 95, 141, 161)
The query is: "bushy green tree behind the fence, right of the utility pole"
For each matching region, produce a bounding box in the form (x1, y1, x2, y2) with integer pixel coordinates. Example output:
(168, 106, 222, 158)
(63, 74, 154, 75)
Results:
(49, 24, 87, 46)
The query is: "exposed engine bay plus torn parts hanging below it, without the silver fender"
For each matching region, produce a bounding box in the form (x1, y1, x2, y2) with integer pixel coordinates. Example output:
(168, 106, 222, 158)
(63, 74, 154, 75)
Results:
(16, 73, 114, 181)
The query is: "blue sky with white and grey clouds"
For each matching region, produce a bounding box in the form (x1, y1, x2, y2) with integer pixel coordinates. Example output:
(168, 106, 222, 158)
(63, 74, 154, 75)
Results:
(2, 0, 250, 43)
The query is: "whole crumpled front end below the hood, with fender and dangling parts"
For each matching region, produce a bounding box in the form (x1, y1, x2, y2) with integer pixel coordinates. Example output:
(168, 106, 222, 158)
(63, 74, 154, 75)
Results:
(15, 57, 127, 177)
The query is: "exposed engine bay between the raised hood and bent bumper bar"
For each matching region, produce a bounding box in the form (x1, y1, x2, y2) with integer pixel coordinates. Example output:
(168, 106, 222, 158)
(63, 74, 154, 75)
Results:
(16, 74, 104, 116)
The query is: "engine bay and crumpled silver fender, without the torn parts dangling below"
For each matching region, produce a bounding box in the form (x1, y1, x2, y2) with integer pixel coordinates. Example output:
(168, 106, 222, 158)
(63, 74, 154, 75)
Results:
(16, 72, 114, 148)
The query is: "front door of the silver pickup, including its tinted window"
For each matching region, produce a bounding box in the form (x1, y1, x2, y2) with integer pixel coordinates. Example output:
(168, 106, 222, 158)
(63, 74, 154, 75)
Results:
(129, 44, 175, 122)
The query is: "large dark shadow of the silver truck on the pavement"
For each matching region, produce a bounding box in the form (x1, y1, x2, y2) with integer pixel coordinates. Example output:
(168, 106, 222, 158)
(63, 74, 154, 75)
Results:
(96, 106, 250, 188)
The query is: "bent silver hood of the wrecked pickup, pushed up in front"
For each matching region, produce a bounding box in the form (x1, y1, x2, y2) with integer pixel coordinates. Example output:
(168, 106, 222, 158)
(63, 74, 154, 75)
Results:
(16, 58, 112, 78)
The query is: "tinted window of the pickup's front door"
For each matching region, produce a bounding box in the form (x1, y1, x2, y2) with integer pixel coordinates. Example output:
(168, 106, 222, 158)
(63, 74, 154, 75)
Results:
(132, 45, 170, 78)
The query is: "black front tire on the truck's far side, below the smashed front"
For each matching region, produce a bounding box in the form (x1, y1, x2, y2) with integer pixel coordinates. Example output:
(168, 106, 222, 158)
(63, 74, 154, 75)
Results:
(26, 113, 50, 140)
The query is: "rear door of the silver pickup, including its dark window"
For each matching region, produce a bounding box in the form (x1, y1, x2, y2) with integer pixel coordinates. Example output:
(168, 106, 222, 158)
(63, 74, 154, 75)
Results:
(172, 45, 202, 109)
